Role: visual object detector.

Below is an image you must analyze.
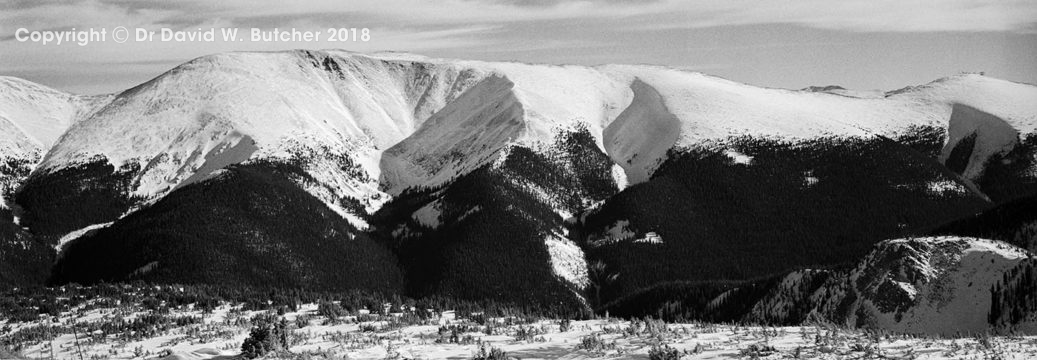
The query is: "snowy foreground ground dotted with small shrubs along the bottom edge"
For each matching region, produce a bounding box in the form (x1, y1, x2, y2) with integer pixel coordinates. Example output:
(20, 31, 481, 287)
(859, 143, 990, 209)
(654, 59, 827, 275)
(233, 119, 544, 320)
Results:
(0, 304, 1037, 359)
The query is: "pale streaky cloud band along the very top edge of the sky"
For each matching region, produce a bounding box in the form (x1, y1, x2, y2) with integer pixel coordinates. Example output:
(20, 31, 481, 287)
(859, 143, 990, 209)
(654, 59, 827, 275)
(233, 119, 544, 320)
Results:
(0, 0, 1037, 38)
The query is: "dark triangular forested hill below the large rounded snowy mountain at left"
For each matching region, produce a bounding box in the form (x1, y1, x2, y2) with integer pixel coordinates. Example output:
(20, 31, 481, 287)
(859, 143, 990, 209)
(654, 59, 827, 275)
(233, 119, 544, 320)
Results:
(51, 162, 402, 293)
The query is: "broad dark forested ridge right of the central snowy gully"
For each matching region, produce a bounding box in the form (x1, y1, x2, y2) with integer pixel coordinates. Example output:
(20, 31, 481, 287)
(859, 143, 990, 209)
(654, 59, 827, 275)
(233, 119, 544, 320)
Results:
(581, 137, 990, 305)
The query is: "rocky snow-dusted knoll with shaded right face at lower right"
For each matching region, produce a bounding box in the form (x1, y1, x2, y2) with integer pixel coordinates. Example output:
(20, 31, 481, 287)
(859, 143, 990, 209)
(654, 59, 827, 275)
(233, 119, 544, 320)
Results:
(813, 237, 1031, 335)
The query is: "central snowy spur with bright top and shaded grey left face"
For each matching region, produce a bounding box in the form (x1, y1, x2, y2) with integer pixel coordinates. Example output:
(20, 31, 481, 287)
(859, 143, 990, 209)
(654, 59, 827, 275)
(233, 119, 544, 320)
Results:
(374, 54, 633, 194)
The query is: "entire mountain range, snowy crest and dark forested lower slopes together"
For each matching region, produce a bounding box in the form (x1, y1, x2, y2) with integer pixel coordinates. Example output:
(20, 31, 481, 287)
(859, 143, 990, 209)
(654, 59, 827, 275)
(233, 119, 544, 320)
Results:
(0, 51, 1037, 324)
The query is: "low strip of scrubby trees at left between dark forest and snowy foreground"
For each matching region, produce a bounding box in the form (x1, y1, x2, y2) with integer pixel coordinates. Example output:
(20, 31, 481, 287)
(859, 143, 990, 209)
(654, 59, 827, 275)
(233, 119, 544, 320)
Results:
(0, 281, 589, 323)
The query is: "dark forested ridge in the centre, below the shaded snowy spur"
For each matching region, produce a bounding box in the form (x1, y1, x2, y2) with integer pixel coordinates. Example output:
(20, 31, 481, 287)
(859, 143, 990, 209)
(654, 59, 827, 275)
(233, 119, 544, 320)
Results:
(373, 128, 617, 312)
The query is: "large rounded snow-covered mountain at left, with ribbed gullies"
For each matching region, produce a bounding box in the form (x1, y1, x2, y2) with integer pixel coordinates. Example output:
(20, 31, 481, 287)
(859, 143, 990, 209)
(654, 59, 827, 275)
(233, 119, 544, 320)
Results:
(28, 51, 487, 227)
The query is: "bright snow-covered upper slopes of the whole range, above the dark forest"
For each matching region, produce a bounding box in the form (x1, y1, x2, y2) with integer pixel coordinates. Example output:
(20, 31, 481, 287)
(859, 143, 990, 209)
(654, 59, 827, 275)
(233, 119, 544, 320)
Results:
(26, 51, 1037, 227)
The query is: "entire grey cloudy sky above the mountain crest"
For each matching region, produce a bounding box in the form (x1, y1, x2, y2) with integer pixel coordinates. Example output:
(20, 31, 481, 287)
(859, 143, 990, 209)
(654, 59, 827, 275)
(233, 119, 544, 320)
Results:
(0, 0, 1037, 93)
